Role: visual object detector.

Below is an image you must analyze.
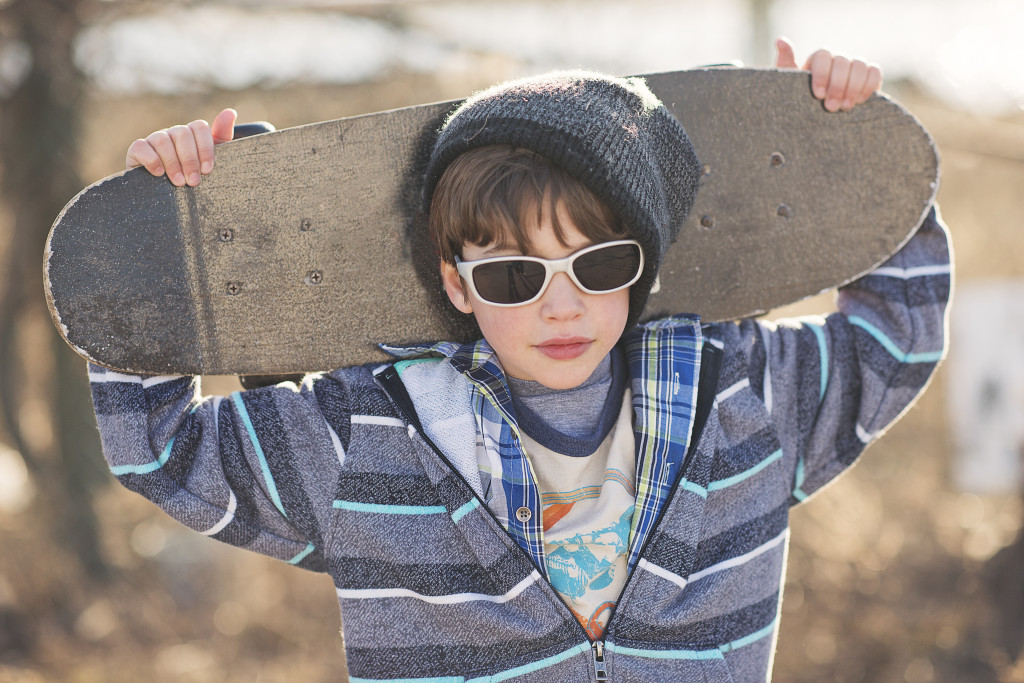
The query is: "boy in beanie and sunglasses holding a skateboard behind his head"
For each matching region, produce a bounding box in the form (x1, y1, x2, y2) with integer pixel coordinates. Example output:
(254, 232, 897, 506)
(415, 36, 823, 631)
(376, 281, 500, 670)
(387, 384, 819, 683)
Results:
(97, 43, 950, 682)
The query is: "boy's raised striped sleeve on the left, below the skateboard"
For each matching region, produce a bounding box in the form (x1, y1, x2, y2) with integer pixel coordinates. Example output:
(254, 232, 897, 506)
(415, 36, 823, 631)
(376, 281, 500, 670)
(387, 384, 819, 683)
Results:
(89, 366, 348, 570)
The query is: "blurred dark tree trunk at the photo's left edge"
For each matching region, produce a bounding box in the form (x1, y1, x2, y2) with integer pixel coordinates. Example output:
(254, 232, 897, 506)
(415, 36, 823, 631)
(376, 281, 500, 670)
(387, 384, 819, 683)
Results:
(0, 0, 106, 578)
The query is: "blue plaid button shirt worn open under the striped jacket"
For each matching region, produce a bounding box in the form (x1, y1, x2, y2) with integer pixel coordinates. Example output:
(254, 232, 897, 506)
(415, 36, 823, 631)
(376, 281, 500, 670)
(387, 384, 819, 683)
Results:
(383, 315, 702, 575)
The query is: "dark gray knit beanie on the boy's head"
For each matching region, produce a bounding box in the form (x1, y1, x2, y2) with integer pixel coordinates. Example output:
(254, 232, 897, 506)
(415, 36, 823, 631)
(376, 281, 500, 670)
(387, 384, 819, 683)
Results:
(425, 72, 700, 329)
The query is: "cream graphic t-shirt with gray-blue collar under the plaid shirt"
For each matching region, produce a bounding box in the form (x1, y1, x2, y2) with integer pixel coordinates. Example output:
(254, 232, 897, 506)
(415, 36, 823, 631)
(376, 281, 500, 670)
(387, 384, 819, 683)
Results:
(509, 350, 636, 640)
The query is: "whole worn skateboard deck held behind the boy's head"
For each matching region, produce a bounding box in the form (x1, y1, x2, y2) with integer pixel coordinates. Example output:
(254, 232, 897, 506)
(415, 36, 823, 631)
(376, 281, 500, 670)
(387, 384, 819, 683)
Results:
(44, 69, 938, 375)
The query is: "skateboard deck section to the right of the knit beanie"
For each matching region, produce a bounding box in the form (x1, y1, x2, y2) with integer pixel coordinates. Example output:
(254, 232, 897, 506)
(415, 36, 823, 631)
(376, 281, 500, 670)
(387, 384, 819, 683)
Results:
(645, 69, 939, 322)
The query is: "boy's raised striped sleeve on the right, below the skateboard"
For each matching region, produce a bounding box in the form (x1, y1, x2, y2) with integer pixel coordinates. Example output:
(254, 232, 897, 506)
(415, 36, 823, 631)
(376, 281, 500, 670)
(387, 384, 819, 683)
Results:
(737, 209, 951, 502)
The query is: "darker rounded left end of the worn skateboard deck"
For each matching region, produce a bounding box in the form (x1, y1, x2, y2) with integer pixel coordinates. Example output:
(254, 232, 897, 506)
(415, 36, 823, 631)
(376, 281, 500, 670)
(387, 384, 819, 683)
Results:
(44, 169, 198, 373)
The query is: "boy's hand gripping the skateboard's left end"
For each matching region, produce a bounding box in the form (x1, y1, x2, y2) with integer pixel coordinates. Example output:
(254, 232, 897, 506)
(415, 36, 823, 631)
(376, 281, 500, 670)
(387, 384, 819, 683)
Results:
(125, 109, 239, 187)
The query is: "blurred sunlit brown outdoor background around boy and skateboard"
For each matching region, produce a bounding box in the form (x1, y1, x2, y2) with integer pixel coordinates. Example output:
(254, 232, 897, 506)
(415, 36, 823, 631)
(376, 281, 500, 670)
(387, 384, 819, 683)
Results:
(0, 0, 1024, 683)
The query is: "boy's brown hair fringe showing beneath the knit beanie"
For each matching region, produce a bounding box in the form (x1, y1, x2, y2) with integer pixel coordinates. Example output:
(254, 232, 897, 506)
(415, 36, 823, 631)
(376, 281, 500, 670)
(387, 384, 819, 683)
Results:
(429, 144, 629, 265)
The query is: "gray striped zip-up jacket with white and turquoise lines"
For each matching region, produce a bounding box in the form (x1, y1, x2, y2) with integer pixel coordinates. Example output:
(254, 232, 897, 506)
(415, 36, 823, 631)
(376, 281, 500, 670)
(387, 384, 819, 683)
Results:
(90, 213, 951, 683)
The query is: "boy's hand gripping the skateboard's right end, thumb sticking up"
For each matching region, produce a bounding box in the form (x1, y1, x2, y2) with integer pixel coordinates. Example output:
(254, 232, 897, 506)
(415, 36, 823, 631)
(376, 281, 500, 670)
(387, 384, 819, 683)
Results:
(775, 38, 882, 112)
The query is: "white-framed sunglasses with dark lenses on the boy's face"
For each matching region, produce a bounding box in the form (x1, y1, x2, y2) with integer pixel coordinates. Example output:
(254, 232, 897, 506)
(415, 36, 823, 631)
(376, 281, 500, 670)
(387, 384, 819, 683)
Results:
(455, 240, 643, 306)
